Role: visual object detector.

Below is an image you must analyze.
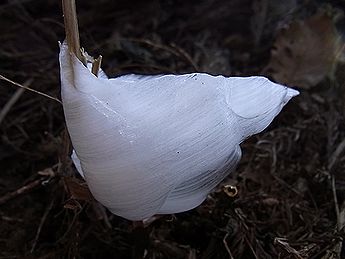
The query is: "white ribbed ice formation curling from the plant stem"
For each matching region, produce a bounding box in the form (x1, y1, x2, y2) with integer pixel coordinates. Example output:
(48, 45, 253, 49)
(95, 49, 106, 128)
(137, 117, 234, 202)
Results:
(60, 45, 298, 220)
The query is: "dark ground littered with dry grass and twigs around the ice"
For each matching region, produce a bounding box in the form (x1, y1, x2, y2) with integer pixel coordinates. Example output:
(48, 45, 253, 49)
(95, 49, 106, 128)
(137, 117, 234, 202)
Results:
(0, 0, 345, 259)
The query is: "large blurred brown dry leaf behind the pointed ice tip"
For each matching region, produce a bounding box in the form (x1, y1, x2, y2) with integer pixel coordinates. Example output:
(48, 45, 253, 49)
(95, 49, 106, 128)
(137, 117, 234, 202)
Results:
(264, 14, 343, 89)
